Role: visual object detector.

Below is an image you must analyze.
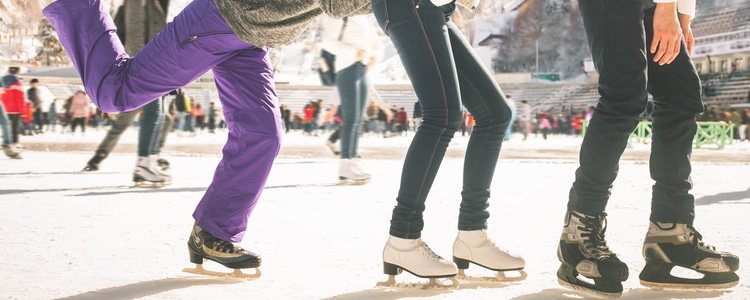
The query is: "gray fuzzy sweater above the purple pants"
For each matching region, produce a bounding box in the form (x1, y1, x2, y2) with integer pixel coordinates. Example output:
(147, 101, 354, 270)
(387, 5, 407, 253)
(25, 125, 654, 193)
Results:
(214, 0, 372, 47)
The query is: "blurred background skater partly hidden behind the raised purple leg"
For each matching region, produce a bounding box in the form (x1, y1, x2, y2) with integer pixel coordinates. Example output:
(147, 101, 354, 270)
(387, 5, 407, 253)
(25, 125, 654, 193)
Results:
(84, 0, 171, 187)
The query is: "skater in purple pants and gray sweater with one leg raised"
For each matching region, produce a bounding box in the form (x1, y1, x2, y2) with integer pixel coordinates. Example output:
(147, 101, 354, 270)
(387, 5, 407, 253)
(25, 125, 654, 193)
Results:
(44, 0, 371, 276)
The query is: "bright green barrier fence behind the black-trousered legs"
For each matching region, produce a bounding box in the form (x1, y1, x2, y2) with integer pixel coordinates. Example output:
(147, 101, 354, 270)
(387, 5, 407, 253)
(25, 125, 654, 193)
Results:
(583, 121, 734, 149)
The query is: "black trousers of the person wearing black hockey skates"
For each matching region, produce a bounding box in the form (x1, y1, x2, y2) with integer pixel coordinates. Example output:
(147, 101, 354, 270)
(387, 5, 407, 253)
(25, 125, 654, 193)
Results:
(568, 0, 703, 224)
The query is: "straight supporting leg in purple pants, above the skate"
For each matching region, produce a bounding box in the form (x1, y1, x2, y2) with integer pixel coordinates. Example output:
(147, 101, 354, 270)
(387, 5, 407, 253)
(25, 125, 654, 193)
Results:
(193, 48, 281, 242)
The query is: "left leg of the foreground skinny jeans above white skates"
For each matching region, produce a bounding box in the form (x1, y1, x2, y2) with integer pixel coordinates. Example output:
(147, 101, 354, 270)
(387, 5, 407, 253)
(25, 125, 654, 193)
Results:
(373, 0, 461, 239)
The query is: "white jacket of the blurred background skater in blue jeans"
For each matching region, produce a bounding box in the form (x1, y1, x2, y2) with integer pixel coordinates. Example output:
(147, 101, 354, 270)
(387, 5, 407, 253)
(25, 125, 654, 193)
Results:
(320, 15, 380, 72)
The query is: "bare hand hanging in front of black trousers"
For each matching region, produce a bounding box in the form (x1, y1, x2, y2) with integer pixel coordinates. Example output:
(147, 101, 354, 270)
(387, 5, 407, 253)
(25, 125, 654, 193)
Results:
(650, 3, 682, 66)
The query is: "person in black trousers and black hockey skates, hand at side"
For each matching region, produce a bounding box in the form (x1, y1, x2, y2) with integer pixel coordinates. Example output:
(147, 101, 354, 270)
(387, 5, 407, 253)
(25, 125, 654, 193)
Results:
(557, 0, 739, 296)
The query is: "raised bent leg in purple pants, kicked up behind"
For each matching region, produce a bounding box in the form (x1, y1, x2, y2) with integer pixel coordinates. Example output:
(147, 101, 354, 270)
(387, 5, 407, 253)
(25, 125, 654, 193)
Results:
(43, 0, 249, 112)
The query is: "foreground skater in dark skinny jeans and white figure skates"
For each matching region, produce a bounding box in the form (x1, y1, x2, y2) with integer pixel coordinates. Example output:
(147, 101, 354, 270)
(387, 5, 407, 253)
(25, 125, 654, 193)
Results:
(372, 0, 524, 284)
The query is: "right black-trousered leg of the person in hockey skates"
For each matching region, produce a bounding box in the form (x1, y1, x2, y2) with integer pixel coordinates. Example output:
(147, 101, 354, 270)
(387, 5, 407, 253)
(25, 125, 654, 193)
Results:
(644, 9, 703, 224)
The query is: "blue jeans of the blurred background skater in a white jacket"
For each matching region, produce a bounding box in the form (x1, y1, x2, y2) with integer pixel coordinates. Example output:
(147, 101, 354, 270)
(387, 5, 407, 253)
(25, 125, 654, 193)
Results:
(336, 62, 367, 158)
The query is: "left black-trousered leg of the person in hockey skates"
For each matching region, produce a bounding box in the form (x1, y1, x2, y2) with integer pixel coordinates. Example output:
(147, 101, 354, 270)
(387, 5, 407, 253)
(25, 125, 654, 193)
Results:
(568, 0, 647, 215)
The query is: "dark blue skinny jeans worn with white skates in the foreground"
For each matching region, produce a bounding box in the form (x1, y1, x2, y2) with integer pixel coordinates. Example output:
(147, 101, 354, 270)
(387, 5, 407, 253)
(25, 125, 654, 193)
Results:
(373, 0, 511, 239)
